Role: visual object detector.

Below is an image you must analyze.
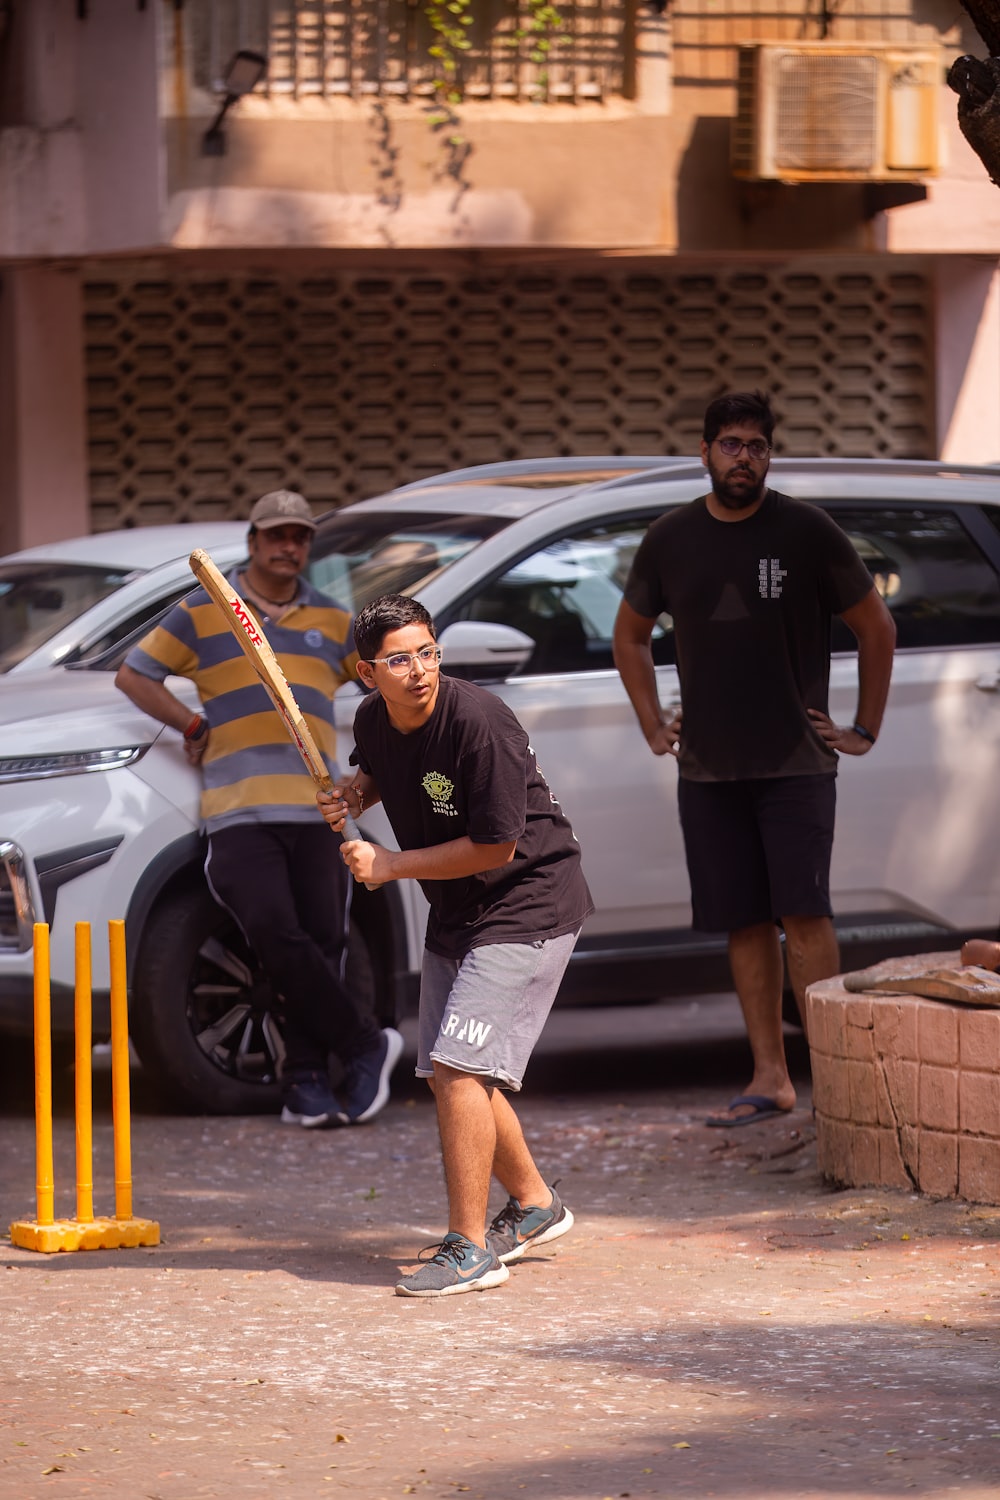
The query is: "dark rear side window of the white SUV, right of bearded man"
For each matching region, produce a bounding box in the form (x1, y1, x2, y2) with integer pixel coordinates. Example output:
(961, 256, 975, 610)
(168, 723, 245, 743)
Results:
(831, 506, 1000, 651)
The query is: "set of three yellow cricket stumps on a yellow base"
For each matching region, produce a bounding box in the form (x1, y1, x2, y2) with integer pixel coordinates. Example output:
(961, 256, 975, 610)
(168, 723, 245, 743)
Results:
(10, 921, 160, 1253)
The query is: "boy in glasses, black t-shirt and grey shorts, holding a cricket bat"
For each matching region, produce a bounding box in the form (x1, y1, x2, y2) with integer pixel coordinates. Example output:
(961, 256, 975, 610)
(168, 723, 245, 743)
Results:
(318, 594, 592, 1298)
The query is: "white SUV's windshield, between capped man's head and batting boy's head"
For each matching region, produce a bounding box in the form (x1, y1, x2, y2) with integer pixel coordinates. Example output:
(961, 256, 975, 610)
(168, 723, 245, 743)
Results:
(309, 510, 508, 614)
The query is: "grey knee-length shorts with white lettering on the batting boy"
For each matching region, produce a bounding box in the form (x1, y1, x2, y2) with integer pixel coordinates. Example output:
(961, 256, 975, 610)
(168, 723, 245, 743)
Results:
(417, 932, 580, 1092)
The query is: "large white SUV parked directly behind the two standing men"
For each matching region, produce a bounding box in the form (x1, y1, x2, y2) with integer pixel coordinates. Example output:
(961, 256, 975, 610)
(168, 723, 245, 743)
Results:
(0, 459, 1000, 1112)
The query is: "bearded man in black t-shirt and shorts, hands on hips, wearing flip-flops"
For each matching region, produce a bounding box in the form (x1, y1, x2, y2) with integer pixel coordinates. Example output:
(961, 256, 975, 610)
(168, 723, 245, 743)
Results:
(615, 392, 895, 1127)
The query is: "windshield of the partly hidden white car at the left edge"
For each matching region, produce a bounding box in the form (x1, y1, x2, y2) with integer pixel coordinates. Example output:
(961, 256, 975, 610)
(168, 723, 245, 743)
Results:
(0, 563, 130, 672)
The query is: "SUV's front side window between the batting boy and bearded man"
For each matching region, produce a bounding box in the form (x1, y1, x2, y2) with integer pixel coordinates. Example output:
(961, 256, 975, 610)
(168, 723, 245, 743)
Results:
(453, 513, 673, 677)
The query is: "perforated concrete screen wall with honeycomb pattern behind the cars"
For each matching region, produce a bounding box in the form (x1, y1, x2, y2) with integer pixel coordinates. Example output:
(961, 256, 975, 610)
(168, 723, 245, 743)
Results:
(85, 258, 934, 530)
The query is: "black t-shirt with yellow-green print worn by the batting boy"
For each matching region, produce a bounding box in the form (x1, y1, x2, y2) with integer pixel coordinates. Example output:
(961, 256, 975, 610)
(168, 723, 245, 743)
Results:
(351, 675, 594, 959)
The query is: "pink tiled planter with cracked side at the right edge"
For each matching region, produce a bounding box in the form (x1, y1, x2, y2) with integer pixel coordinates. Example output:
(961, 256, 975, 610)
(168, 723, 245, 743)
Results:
(805, 953, 1000, 1205)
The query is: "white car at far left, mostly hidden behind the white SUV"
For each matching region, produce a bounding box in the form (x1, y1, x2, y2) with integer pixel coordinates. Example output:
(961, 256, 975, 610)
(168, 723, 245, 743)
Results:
(0, 521, 247, 674)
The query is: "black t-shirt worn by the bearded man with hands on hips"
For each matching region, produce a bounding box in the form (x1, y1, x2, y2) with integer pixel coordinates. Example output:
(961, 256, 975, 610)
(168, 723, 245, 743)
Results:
(625, 489, 873, 782)
